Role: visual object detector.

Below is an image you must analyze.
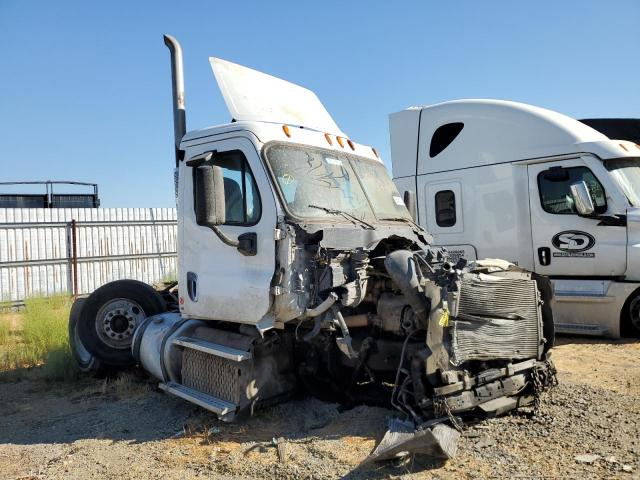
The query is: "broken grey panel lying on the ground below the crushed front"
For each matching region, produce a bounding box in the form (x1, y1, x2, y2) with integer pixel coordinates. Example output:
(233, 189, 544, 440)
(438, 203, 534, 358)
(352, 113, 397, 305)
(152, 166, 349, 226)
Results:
(362, 418, 460, 465)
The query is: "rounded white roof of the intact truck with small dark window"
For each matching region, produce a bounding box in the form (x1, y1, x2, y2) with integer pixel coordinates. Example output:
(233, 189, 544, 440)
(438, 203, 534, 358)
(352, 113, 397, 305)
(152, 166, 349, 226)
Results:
(389, 99, 640, 178)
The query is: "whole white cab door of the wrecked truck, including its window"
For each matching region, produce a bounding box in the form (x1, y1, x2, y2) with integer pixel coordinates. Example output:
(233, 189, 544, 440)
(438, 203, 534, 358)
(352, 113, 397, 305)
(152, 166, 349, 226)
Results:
(178, 137, 276, 324)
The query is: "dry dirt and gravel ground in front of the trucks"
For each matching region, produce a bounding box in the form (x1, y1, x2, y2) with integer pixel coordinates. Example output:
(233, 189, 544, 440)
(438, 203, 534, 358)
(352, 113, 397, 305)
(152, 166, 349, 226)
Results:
(0, 337, 640, 480)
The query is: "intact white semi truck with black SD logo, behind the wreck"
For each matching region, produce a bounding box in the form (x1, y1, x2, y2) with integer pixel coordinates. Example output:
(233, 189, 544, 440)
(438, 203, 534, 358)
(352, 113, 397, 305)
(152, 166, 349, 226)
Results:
(389, 100, 640, 337)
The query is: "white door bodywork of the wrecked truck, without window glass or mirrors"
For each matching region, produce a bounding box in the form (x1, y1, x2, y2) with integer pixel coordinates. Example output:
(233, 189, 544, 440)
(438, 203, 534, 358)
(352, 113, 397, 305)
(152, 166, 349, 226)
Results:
(178, 137, 276, 324)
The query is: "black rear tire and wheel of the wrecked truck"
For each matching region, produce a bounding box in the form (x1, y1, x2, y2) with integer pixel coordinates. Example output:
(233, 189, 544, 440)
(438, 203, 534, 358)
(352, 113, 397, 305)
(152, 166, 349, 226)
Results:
(76, 280, 166, 373)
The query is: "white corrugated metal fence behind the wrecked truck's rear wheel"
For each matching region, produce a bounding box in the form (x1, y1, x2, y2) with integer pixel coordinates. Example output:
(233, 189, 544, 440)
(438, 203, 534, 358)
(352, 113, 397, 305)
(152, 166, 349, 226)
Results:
(0, 208, 177, 304)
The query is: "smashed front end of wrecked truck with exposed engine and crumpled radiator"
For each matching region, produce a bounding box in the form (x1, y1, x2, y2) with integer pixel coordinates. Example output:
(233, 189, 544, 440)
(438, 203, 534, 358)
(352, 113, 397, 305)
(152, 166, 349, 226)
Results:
(274, 225, 554, 461)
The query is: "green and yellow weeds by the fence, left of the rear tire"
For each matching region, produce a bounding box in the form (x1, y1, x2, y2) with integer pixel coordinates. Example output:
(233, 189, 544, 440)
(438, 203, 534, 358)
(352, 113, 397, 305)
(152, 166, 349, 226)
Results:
(0, 296, 77, 380)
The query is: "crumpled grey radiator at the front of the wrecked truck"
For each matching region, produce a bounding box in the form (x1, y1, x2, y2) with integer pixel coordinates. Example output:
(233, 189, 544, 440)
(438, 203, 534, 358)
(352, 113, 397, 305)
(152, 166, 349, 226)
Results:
(452, 274, 542, 364)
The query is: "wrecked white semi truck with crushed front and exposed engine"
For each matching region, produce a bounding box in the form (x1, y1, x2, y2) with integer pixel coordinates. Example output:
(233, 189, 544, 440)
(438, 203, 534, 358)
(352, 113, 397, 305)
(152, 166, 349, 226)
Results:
(70, 36, 554, 458)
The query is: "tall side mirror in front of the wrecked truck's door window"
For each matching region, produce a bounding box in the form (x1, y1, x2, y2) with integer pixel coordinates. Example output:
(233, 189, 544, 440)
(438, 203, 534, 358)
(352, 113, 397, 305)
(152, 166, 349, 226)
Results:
(194, 164, 226, 227)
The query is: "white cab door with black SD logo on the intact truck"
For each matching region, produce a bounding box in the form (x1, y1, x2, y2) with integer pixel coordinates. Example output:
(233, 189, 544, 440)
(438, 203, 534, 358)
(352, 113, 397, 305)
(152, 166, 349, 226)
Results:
(527, 158, 627, 277)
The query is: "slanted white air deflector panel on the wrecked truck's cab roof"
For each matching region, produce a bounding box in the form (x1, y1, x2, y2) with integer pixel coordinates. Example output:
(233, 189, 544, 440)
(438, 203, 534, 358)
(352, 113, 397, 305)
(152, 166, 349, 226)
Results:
(209, 57, 346, 136)
